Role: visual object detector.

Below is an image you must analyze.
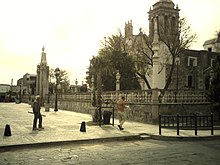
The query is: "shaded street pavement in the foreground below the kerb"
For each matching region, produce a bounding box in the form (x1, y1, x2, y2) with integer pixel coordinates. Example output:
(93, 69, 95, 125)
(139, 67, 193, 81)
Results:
(0, 140, 220, 165)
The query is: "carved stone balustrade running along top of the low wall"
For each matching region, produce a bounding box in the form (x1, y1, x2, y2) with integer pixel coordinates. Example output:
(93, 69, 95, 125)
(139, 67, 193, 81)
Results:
(23, 90, 209, 104)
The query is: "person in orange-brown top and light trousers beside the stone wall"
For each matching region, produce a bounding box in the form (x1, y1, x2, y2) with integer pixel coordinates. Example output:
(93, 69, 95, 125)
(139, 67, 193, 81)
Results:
(117, 96, 126, 130)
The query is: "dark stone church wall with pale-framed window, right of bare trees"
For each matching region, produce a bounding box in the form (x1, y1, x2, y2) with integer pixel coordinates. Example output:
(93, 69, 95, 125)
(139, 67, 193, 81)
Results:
(167, 50, 220, 90)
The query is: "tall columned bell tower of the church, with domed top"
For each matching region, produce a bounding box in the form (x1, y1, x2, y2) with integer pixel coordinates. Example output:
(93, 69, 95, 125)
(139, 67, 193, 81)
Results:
(148, 0, 180, 42)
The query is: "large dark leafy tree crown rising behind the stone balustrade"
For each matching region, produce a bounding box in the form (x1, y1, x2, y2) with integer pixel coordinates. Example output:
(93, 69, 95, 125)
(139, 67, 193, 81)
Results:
(87, 36, 140, 91)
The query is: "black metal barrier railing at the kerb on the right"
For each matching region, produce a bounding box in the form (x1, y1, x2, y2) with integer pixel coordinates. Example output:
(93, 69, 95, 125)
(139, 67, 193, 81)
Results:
(159, 114, 214, 135)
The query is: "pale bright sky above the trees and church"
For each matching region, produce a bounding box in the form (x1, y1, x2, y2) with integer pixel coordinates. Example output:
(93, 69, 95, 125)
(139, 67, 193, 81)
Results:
(0, 0, 220, 85)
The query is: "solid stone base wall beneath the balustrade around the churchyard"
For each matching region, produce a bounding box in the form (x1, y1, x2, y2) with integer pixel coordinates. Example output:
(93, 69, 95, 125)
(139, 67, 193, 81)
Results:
(22, 94, 211, 123)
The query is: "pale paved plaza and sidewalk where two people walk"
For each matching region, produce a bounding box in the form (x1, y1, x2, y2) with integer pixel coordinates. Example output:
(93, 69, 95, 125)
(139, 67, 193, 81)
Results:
(0, 103, 220, 148)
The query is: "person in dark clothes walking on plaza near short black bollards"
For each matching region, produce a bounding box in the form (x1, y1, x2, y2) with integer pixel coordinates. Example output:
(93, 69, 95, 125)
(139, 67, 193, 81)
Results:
(33, 95, 44, 131)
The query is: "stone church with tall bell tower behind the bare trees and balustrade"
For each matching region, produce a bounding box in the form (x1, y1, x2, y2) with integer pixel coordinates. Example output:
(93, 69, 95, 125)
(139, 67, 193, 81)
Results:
(125, 0, 220, 90)
